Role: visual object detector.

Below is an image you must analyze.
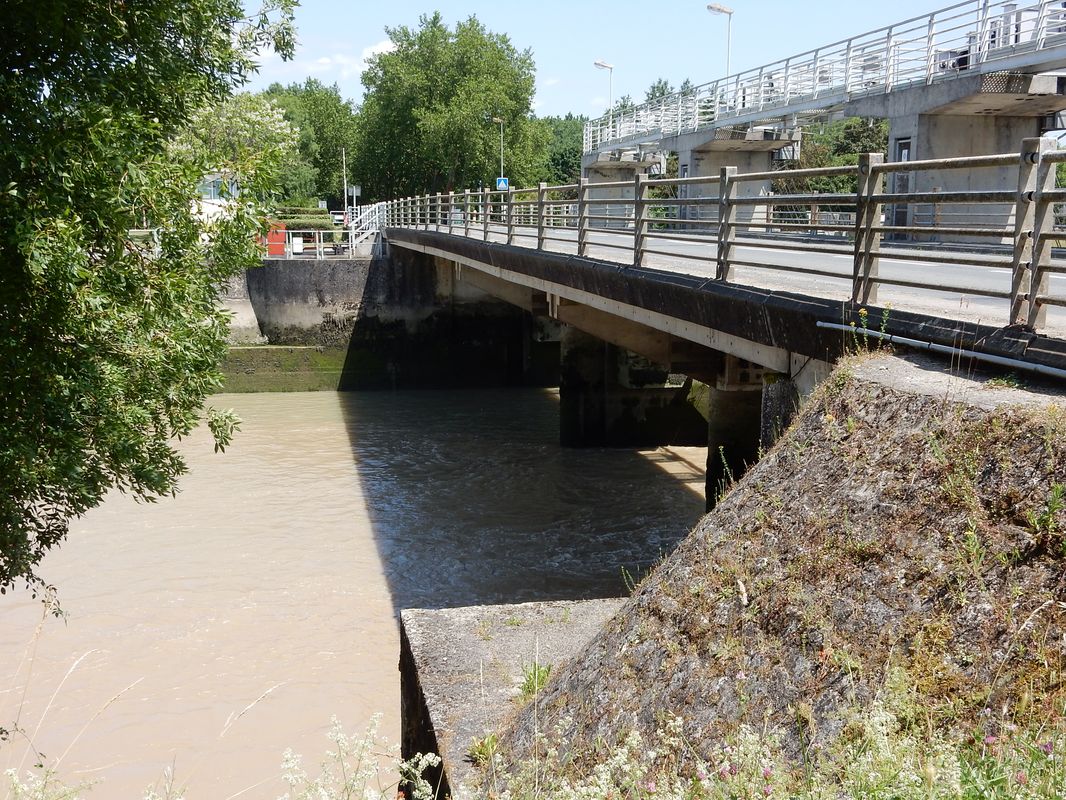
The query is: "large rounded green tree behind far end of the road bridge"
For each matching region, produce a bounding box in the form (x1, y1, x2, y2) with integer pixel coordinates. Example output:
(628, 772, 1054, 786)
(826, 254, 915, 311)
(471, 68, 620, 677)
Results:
(356, 14, 548, 197)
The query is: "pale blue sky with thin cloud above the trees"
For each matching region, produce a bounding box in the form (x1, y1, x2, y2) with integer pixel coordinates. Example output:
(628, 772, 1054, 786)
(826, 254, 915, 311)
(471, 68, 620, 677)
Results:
(249, 0, 967, 116)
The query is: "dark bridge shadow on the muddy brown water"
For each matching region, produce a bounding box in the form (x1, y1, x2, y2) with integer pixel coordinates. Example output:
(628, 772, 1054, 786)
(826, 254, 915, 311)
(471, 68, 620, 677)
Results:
(337, 388, 704, 611)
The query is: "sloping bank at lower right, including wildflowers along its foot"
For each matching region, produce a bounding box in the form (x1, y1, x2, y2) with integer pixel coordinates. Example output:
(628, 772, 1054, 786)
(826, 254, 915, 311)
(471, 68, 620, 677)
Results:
(485, 356, 1066, 799)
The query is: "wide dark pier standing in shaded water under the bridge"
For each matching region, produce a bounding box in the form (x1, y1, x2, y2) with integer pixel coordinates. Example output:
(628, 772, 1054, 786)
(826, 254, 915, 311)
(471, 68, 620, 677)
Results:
(559, 325, 707, 447)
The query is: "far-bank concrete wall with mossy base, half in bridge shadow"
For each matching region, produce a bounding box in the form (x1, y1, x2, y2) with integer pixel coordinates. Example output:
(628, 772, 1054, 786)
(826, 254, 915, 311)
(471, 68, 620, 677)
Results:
(224, 251, 559, 391)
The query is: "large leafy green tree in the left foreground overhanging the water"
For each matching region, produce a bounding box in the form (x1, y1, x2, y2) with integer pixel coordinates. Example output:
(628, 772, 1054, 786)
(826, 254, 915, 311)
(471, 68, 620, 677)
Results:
(0, 0, 293, 591)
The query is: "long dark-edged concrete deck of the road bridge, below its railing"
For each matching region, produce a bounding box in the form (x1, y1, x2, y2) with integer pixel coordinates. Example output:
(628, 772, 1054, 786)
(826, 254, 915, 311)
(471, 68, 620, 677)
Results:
(385, 228, 1066, 385)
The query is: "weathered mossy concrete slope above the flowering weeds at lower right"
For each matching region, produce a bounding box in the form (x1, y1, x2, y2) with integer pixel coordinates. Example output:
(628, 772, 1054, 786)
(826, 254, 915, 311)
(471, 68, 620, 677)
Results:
(407, 355, 1066, 788)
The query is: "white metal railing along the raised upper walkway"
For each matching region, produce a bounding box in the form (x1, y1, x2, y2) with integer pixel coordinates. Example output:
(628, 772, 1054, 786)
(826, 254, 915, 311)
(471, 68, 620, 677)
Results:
(584, 0, 1066, 153)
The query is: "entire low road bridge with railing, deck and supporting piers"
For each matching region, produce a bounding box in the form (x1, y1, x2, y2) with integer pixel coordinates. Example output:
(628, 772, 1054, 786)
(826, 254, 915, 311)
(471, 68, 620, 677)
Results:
(347, 139, 1066, 495)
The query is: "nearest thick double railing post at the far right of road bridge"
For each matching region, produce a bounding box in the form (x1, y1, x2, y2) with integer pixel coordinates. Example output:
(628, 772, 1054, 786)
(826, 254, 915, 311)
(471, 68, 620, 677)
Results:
(1011, 139, 1055, 331)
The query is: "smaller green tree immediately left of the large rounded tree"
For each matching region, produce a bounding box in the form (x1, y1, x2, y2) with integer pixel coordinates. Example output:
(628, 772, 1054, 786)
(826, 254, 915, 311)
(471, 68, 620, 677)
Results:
(264, 78, 358, 208)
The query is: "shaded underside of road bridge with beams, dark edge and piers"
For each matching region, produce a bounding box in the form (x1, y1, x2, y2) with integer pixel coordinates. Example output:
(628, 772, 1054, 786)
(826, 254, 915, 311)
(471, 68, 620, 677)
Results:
(386, 228, 1061, 502)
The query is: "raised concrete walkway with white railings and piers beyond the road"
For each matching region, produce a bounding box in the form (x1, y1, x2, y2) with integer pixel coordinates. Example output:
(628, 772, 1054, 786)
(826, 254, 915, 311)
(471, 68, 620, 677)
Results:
(582, 0, 1066, 241)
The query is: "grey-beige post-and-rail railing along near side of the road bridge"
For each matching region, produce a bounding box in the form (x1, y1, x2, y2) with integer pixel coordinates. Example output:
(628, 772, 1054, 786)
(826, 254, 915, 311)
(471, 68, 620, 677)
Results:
(381, 139, 1066, 330)
